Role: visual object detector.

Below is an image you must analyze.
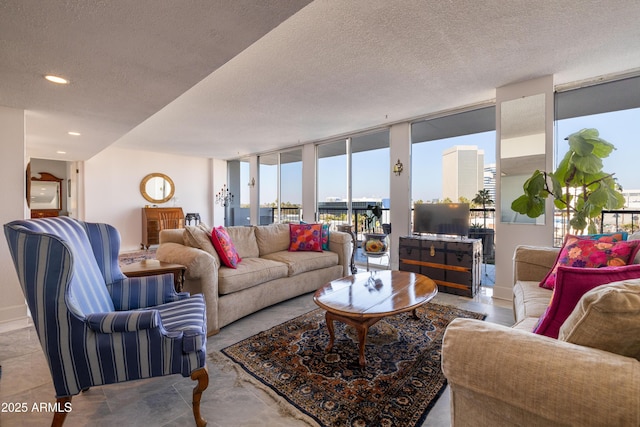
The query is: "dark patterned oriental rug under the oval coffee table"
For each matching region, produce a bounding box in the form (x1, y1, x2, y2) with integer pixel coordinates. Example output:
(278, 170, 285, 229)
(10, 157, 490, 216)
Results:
(222, 303, 485, 427)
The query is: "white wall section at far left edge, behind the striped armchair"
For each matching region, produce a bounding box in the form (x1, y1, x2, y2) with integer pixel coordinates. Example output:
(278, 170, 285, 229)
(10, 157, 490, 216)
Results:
(0, 107, 29, 323)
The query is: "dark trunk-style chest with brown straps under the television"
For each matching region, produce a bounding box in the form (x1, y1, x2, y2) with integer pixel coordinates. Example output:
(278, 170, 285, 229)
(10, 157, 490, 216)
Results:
(398, 235, 482, 298)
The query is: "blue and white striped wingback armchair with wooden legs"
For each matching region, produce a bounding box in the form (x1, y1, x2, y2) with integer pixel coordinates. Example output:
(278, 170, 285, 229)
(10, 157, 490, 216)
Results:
(4, 217, 209, 426)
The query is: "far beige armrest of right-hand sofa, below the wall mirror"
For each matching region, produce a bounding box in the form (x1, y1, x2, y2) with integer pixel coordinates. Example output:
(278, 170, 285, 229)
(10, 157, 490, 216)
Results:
(513, 245, 560, 283)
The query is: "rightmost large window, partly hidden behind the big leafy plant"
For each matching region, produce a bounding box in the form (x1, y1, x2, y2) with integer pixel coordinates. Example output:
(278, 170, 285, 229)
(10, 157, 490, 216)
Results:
(554, 77, 640, 245)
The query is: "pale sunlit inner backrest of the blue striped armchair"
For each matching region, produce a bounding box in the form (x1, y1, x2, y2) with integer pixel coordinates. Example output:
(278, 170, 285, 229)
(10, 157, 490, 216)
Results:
(9, 217, 114, 315)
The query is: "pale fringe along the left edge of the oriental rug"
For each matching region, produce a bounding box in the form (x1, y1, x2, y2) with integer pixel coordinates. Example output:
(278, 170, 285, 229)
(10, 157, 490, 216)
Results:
(207, 351, 321, 427)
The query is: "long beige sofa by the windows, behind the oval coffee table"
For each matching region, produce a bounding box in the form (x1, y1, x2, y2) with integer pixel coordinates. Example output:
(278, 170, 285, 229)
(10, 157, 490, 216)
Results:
(156, 224, 352, 335)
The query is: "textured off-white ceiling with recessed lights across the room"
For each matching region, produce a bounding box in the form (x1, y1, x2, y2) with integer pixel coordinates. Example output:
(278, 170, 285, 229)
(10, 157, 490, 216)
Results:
(0, 0, 640, 160)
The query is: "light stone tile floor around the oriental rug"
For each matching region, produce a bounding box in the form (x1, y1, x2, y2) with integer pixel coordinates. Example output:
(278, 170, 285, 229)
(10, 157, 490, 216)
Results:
(0, 266, 513, 427)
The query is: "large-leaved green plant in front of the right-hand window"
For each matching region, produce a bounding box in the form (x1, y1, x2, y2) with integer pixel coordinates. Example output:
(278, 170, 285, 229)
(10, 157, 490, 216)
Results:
(511, 129, 624, 233)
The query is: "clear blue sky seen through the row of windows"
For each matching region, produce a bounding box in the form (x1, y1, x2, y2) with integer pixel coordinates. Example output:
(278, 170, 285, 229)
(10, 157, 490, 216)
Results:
(241, 109, 640, 207)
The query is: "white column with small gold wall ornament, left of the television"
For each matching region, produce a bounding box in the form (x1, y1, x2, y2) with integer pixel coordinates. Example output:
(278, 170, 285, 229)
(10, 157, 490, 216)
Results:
(389, 123, 411, 270)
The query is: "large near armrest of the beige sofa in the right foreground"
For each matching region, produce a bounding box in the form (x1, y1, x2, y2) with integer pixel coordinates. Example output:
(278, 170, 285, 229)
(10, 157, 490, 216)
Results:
(442, 319, 640, 426)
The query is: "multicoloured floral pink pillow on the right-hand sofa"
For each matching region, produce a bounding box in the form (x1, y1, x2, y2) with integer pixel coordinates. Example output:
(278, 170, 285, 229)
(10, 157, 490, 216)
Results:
(540, 233, 640, 289)
